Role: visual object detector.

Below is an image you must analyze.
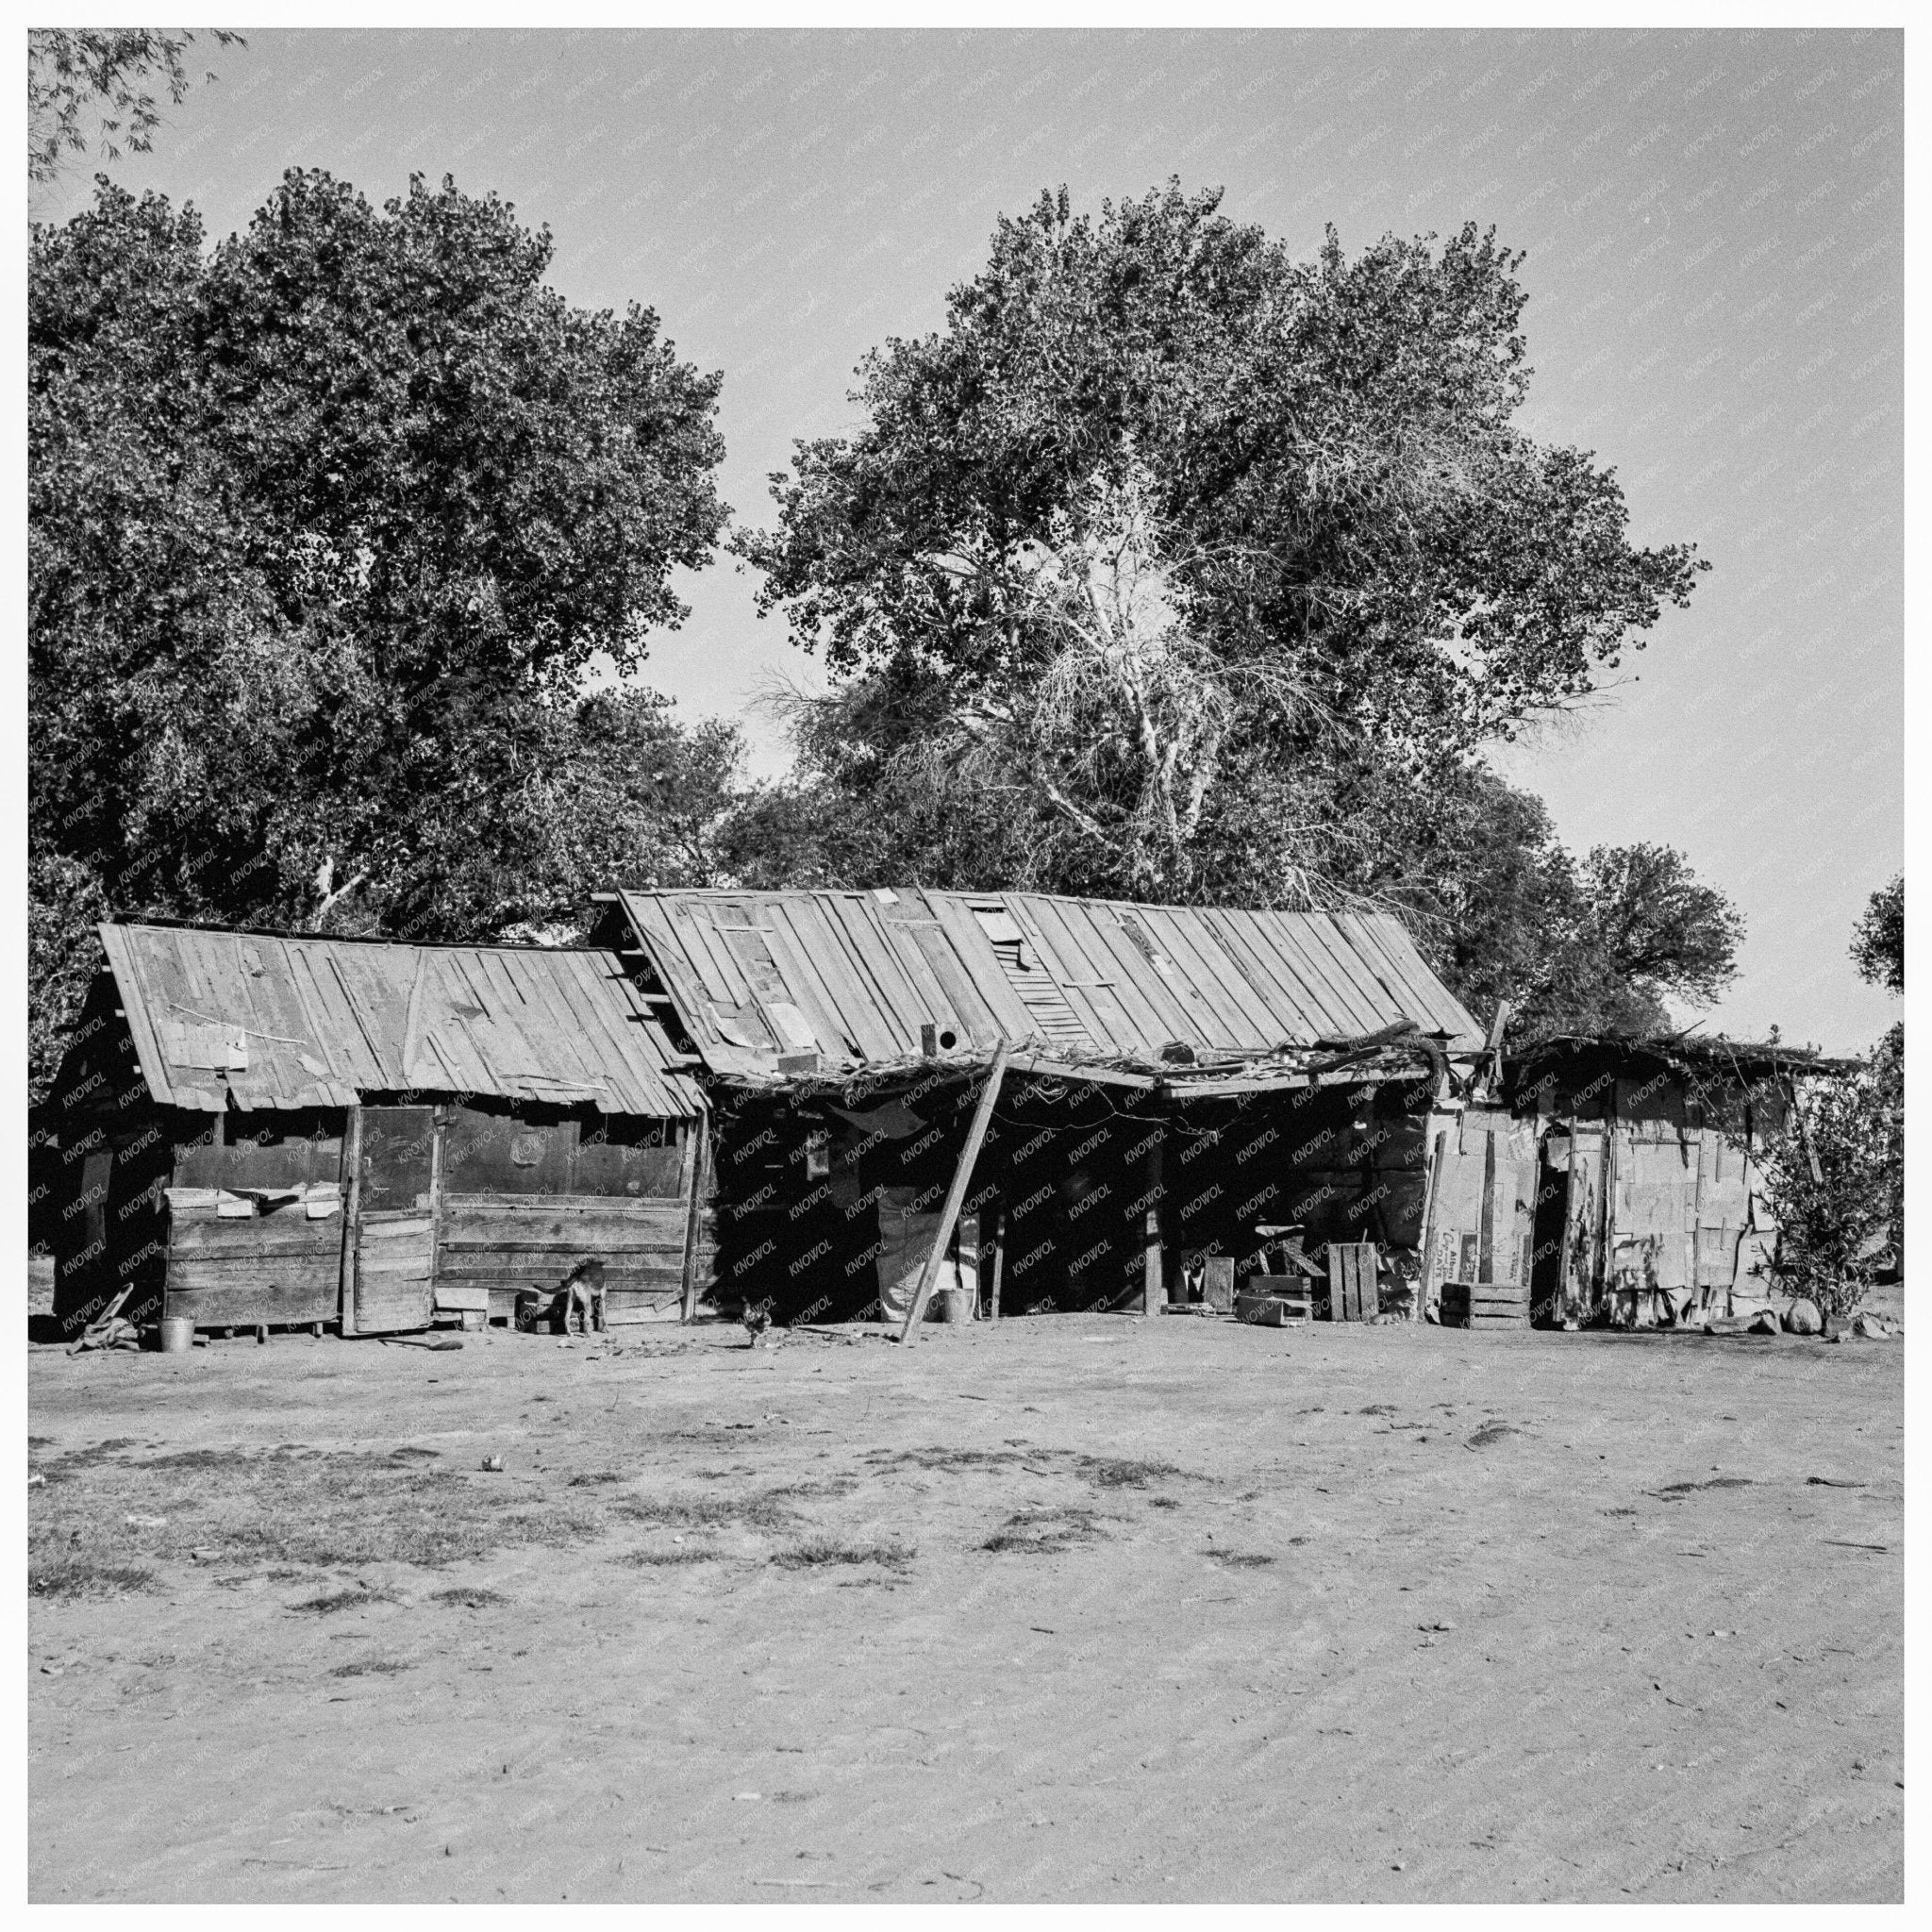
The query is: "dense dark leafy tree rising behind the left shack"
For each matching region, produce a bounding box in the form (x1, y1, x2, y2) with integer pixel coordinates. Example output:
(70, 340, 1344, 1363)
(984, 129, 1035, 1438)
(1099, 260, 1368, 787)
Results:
(29, 172, 726, 1090)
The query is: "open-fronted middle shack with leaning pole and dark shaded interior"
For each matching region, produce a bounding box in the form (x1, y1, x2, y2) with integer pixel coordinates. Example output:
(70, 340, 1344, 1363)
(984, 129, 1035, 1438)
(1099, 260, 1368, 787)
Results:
(597, 887, 1482, 1320)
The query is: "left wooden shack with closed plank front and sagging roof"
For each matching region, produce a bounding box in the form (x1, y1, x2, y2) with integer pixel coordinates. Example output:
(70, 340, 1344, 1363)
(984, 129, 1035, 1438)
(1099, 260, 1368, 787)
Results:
(37, 924, 711, 1335)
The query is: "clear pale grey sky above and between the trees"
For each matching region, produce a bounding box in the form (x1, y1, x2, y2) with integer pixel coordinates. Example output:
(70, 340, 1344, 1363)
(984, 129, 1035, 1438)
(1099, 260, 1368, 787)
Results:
(33, 31, 1903, 1051)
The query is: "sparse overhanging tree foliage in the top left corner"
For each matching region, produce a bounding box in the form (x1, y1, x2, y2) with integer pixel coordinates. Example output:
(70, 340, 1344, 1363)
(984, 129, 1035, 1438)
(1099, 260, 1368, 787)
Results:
(27, 27, 247, 182)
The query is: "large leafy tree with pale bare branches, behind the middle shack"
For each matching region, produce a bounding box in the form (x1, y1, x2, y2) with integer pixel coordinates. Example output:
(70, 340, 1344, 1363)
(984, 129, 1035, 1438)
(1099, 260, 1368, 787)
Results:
(740, 184, 1740, 1034)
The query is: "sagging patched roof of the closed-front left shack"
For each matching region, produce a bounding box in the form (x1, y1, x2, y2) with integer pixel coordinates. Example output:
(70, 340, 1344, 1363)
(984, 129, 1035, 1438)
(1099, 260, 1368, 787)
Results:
(100, 925, 703, 1119)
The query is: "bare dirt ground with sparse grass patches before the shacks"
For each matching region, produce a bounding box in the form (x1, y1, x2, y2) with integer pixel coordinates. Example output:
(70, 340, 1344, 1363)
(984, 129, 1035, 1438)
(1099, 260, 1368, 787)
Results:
(27, 1316, 1905, 1901)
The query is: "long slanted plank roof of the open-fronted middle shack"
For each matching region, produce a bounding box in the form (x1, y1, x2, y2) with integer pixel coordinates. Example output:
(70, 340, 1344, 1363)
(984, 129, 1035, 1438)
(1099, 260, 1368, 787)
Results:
(618, 889, 1482, 1074)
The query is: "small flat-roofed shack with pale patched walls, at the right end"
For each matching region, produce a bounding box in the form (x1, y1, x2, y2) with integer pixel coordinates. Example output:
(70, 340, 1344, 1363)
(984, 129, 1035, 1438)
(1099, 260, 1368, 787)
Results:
(1503, 1036, 1845, 1327)
